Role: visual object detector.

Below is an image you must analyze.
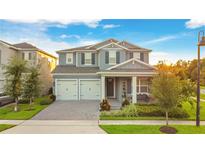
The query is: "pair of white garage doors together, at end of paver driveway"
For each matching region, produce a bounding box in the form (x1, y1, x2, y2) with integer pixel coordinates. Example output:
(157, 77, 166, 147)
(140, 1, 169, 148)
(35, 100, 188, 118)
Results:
(55, 79, 101, 100)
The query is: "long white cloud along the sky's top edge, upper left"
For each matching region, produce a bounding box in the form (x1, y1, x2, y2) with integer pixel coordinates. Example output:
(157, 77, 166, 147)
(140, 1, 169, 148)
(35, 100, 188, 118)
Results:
(7, 19, 101, 28)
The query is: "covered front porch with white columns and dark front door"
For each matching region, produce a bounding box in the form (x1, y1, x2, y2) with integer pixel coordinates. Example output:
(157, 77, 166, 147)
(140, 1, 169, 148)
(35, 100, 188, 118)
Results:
(101, 76, 152, 106)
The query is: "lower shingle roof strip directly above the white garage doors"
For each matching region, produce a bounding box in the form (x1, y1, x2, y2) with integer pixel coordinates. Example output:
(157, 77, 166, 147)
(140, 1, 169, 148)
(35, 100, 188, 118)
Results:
(52, 65, 99, 73)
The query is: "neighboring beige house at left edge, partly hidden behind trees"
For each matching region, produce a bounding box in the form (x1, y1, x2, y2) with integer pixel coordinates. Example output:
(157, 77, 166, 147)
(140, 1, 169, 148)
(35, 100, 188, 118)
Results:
(0, 40, 57, 93)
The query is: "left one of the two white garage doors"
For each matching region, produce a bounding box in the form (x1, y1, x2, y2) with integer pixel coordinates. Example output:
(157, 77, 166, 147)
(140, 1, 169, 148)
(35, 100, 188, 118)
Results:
(57, 80, 78, 100)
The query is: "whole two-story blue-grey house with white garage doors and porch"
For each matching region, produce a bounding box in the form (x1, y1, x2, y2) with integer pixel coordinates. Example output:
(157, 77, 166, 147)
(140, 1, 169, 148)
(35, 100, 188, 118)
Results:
(52, 39, 156, 103)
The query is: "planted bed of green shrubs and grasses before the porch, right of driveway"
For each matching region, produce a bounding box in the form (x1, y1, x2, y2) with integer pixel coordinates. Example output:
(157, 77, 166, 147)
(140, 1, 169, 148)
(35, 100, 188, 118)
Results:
(100, 103, 191, 120)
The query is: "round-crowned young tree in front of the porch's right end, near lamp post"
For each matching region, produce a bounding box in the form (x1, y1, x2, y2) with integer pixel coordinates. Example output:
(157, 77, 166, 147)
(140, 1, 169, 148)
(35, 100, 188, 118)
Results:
(151, 71, 182, 125)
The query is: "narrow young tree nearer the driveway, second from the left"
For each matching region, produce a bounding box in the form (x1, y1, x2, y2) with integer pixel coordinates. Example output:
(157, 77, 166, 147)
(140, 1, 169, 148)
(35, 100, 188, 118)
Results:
(23, 67, 40, 109)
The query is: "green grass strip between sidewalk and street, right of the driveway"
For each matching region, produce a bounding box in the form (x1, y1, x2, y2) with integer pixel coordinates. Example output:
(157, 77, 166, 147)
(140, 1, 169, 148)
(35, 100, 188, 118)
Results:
(100, 125, 205, 134)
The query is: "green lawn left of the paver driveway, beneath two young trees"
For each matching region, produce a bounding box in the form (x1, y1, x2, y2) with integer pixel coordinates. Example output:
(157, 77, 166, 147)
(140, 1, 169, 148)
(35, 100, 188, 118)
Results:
(0, 96, 48, 120)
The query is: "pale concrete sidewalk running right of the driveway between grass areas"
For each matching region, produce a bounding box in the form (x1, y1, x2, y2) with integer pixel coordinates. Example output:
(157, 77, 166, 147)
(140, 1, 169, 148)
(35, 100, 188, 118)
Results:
(99, 120, 205, 125)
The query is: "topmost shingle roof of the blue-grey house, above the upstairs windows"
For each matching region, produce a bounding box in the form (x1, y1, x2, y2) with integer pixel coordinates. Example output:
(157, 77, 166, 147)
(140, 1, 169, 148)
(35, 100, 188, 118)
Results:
(57, 39, 151, 52)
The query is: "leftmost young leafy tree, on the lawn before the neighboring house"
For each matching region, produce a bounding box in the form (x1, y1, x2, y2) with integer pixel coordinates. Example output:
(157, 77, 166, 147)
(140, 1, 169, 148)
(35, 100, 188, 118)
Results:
(3, 57, 26, 111)
